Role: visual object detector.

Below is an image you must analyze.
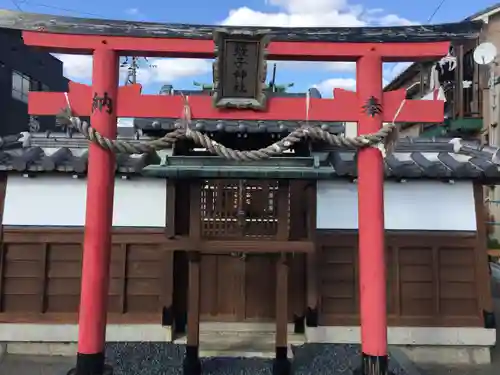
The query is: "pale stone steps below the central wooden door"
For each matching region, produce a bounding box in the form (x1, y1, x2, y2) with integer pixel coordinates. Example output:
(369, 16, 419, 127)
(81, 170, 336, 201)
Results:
(173, 323, 306, 359)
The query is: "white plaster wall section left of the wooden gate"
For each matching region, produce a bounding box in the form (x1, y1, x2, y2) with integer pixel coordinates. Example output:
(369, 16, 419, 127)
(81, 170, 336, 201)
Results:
(3, 175, 167, 227)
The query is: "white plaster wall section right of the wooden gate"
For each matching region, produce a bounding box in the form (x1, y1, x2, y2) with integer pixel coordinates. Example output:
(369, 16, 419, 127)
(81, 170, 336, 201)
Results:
(316, 181, 477, 231)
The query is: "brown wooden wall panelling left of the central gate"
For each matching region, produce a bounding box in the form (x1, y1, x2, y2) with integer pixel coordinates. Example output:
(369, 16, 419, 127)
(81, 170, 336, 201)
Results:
(0, 228, 173, 323)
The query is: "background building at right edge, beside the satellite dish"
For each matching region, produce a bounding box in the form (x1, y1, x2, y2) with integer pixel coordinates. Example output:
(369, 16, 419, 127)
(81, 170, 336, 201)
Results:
(385, 3, 500, 247)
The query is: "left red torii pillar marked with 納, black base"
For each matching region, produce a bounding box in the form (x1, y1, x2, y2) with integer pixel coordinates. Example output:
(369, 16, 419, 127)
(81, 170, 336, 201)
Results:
(72, 47, 118, 375)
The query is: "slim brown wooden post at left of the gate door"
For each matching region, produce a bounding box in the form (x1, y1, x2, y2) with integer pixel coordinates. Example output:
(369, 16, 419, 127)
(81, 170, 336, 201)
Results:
(183, 181, 201, 375)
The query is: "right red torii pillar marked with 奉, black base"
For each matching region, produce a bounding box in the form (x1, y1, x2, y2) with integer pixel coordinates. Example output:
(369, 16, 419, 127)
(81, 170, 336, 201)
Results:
(356, 51, 388, 375)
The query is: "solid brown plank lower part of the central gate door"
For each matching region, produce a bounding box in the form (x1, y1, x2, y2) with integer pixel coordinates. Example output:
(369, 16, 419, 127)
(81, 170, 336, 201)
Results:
(200, 253, 276, 322)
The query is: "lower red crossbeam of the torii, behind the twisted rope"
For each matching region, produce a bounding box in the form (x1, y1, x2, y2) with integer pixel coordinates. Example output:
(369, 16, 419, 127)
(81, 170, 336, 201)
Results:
(29, 82, 444, 122)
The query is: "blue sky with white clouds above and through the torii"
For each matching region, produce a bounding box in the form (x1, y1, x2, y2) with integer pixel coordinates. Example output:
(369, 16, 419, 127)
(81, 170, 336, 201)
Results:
(0, 0, 494, 96)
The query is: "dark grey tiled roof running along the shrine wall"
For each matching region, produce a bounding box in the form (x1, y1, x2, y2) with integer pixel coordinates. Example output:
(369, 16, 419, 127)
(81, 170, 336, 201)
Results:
(0, 133, 500, 182)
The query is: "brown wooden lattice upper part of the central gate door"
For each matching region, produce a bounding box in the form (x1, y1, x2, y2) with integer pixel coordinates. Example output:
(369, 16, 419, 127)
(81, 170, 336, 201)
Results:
(200, 180, 288, 239)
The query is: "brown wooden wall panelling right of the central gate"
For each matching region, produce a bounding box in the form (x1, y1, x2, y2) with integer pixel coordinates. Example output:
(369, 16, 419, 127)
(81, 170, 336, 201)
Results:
(317, 231, 486, 326)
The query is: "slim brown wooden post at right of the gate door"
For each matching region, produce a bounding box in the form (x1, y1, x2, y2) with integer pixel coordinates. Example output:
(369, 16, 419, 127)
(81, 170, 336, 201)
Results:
(273, 180, 291, 375)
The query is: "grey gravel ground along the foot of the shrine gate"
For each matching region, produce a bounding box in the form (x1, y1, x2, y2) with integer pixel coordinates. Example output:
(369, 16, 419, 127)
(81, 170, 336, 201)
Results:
(0, 343, 409, 375)
